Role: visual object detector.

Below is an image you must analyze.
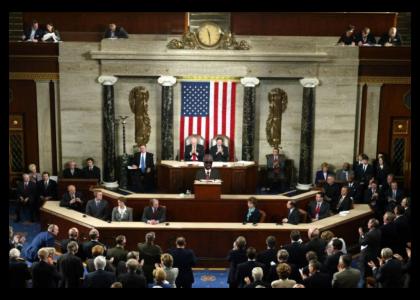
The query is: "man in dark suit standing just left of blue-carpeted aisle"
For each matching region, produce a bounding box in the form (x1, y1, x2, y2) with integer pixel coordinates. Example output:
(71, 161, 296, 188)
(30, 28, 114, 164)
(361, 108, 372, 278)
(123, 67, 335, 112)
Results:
(168, 237, 197, 288)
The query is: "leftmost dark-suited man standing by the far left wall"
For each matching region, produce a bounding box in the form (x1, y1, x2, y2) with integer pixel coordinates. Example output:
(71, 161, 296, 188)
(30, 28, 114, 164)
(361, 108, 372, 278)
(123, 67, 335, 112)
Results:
(15, 174, 38, 222)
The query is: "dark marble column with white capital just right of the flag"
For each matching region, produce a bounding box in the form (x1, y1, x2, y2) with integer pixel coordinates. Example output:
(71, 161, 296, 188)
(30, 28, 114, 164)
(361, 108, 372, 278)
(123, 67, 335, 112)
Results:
(241, 77, 260, 161)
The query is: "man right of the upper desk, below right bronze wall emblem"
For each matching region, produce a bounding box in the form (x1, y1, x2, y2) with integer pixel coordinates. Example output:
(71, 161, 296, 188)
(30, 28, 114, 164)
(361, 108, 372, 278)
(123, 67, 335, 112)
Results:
(266, 148, 286, 193)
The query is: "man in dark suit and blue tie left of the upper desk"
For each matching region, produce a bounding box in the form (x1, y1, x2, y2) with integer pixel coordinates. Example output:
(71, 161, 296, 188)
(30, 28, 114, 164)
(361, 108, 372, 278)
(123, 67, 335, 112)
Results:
(131, 145, 155, 192)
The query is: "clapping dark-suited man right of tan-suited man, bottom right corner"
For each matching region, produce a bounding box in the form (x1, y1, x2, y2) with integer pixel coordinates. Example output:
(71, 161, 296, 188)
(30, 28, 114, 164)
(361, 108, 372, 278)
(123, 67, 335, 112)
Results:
(368, 248, 403, 288)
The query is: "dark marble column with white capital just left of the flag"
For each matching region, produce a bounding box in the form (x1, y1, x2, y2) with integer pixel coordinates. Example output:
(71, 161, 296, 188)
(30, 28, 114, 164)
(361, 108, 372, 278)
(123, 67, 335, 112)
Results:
(158, 76, 176, 160)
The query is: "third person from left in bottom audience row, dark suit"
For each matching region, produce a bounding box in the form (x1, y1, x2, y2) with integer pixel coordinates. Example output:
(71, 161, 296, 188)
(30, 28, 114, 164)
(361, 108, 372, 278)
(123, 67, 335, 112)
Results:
(57, 241, 84, 288)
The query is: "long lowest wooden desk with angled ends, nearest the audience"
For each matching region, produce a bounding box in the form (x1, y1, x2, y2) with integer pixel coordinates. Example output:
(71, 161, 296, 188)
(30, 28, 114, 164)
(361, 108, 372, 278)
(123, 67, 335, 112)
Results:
(41, 201, 372, 267)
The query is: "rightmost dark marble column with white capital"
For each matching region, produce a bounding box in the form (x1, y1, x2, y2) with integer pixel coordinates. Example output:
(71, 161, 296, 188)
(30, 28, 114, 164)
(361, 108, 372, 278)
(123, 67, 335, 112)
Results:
(296, 78, 319, 190)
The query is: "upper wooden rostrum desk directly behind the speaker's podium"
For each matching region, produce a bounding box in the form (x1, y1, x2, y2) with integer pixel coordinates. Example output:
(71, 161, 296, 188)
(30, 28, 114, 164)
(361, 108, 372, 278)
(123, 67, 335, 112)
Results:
(157, 160, 258, 194)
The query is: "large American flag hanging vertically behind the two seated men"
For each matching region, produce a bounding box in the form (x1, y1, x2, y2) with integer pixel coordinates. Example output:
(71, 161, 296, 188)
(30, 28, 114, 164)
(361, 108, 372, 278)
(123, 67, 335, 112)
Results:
(179, 81, 236, 161)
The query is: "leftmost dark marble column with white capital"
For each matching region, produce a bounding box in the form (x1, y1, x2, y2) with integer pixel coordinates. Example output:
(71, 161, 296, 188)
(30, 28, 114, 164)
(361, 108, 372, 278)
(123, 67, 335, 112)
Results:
(98, 76, 118, 188)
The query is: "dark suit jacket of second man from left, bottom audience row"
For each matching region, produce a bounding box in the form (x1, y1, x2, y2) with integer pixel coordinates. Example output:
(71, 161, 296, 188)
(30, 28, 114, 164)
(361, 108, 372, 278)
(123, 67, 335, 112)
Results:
(32, 261, 61, 288)
